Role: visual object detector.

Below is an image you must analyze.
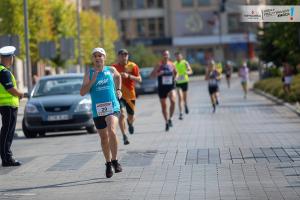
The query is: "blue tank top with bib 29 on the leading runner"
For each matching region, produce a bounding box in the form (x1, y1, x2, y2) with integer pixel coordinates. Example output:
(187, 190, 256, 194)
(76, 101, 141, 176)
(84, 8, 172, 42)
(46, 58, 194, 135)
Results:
(90, 66, 120, 117)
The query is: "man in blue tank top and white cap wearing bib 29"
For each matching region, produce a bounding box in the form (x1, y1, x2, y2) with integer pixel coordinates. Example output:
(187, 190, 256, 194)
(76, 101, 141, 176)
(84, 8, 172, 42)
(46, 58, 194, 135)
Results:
(80, 48, 122, 178)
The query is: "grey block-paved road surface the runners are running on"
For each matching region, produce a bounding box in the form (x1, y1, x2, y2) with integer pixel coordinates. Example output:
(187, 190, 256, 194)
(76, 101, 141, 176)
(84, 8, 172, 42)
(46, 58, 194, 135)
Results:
(0, 74, 300, 200)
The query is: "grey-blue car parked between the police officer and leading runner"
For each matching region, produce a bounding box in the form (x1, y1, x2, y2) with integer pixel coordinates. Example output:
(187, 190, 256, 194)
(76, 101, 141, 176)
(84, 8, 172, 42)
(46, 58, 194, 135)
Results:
(22, 74, 97, 138)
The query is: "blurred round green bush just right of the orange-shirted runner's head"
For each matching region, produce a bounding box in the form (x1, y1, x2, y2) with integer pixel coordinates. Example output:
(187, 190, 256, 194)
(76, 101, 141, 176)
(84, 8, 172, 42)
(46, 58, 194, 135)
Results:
(128, 45, 159, 68)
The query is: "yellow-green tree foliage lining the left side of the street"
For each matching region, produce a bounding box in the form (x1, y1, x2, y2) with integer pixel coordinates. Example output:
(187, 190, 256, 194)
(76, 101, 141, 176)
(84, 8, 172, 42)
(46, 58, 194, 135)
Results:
(0, 0, 119, 67)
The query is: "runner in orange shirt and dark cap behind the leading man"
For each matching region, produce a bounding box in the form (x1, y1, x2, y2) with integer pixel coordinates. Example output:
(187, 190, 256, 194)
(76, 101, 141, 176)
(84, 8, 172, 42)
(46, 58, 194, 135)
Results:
(113, 49, 142, 145)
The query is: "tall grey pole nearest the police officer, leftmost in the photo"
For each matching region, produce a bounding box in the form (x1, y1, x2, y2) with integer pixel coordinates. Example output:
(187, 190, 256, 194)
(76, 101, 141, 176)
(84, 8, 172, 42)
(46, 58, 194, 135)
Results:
(23, 0, 32, 95)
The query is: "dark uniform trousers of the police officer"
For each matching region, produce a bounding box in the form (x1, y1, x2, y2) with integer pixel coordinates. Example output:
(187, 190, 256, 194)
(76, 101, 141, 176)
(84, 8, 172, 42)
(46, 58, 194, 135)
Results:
(0, 106, 18, 162)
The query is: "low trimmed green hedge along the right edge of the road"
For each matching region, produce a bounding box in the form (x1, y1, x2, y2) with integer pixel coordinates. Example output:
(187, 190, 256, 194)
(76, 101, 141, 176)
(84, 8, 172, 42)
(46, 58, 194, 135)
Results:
(254, 75, 300, 103)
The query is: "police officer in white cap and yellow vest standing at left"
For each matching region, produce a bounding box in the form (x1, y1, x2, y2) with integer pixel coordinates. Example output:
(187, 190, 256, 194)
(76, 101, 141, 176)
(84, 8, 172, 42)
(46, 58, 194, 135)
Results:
(0, 46, 24, 167)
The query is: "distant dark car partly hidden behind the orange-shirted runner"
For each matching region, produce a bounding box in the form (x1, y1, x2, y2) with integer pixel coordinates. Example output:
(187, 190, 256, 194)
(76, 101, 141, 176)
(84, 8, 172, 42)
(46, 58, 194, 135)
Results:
(136, 67, 158, 95)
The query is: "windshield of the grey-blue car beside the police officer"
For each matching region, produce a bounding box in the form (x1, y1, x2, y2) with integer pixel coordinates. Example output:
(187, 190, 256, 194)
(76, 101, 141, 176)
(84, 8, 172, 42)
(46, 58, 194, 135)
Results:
(33, 77, 83, 97)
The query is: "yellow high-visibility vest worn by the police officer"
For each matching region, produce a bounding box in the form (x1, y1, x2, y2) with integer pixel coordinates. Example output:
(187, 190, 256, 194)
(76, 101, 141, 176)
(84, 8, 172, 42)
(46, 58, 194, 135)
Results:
(0, 65, 19, 108)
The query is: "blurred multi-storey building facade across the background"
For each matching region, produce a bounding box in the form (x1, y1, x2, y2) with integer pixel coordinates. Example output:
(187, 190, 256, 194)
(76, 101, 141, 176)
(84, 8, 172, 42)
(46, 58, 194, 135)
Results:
(82, 0, 266, 64)
